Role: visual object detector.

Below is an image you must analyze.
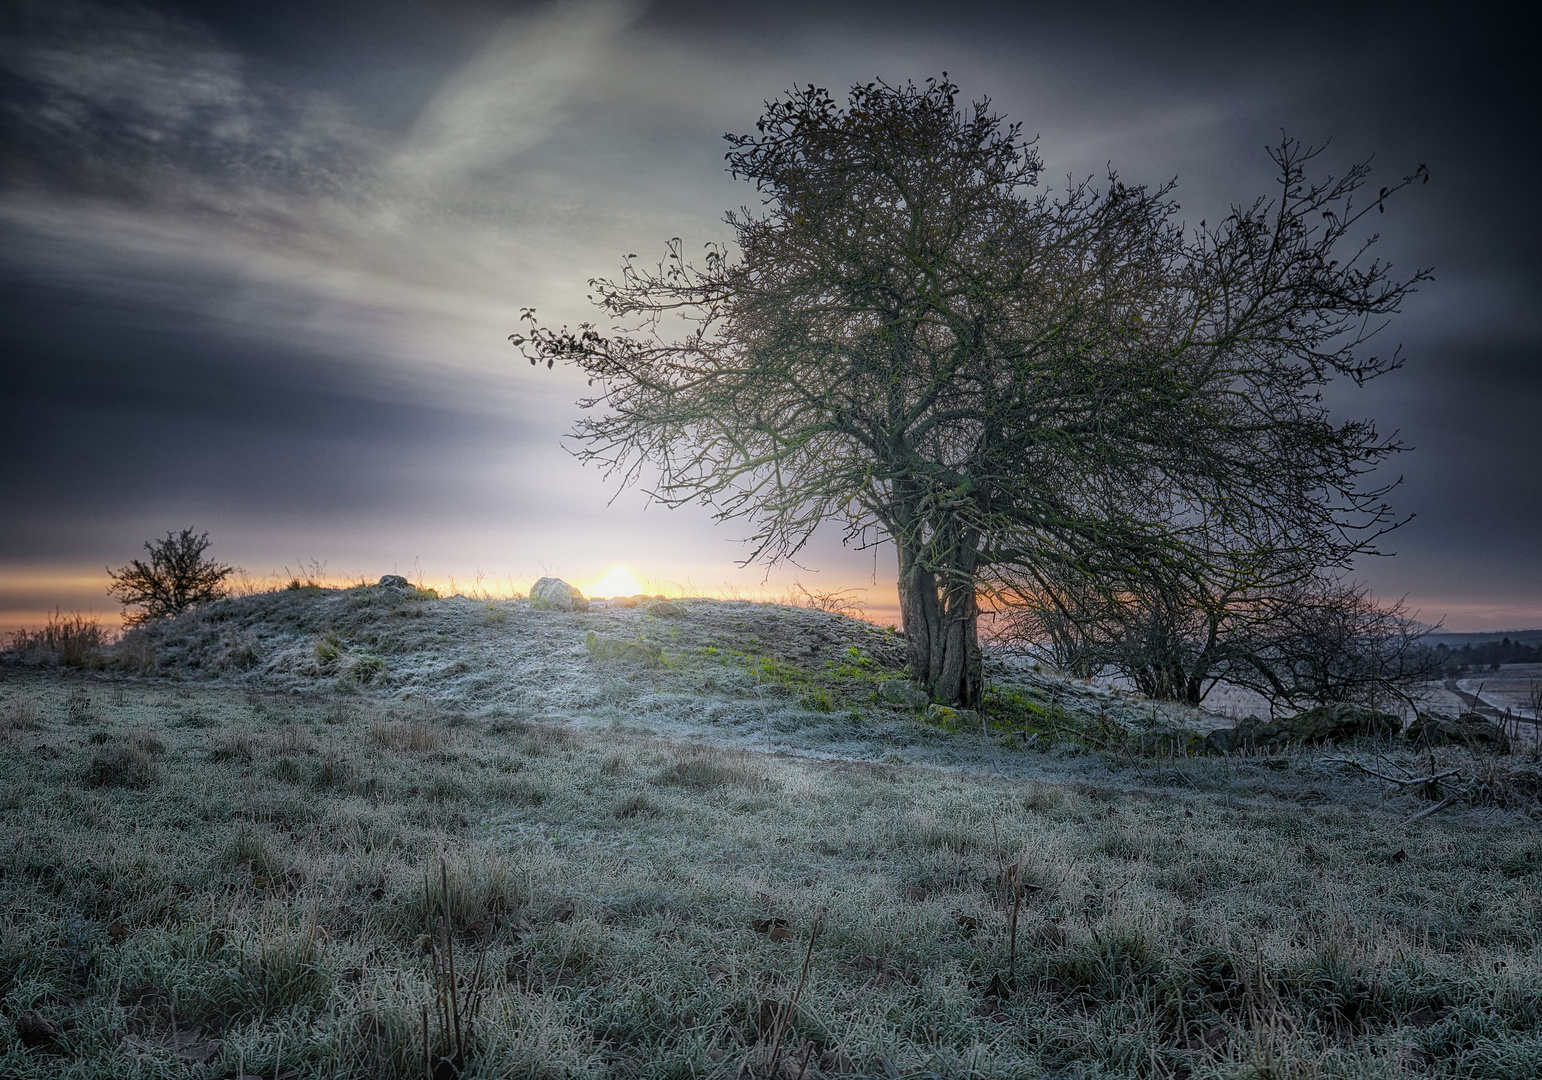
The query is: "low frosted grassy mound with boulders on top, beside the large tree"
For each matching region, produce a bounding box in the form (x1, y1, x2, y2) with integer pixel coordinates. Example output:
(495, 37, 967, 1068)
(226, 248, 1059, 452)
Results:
(96, 586, 1226, 775)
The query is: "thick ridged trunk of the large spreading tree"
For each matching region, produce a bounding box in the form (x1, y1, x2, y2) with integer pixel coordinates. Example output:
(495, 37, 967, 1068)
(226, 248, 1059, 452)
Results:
(899, 545, 985, 708)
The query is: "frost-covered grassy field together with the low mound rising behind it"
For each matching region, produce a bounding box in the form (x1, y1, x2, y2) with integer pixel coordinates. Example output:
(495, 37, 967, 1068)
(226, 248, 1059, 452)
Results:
(0, 591, 1542, 1078)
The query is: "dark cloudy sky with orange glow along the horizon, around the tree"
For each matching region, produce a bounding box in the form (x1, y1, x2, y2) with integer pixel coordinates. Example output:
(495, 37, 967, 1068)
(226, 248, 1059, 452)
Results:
(0, 0, 1542, 631)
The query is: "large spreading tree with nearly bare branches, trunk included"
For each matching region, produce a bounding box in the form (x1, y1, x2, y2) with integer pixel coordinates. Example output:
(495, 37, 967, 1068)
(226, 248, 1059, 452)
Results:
(510, 77, 1420, 705)
